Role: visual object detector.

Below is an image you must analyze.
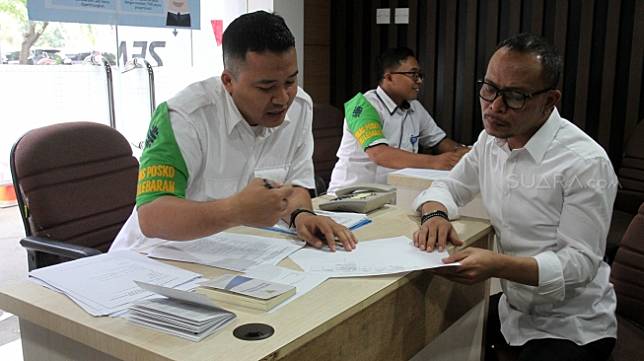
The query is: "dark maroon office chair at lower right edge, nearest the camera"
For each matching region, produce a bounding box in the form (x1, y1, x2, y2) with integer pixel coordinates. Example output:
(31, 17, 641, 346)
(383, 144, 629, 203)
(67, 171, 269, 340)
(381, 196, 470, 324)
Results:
(610, 203, 644, 361)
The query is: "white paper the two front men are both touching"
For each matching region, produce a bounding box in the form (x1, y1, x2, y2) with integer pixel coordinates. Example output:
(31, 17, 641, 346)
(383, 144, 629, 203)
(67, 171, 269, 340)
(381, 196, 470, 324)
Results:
(291, 237, 458, 277)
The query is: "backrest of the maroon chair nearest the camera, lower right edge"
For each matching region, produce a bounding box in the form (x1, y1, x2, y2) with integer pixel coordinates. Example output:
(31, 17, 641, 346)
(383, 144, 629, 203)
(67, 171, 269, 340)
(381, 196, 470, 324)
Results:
(610, 203, 644, 326)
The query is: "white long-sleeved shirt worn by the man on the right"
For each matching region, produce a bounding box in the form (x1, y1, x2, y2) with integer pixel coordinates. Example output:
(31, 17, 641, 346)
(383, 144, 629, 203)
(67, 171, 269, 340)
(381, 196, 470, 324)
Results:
(414, 109, 617, 346)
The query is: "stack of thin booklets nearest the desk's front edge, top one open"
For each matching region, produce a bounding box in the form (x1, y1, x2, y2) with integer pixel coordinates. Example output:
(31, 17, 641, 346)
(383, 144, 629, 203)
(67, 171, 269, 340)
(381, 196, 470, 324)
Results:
(126, 282, 236, 341)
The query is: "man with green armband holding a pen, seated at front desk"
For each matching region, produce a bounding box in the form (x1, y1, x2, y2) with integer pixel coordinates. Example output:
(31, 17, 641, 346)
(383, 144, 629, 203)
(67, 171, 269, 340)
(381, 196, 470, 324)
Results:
(111, 11, 356, 250)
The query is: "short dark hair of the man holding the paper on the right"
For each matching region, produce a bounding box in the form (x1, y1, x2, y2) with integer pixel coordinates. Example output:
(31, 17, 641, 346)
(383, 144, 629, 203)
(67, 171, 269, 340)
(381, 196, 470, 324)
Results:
(496, 33, 563, 89)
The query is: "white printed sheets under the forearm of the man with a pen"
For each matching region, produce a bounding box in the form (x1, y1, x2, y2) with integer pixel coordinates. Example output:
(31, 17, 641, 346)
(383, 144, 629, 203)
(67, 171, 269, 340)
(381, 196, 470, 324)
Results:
(148, 232, 304, 272)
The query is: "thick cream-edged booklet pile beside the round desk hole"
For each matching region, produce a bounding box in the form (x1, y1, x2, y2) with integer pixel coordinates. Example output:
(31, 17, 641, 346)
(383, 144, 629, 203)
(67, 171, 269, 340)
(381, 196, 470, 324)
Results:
(200, 274, 296, 311)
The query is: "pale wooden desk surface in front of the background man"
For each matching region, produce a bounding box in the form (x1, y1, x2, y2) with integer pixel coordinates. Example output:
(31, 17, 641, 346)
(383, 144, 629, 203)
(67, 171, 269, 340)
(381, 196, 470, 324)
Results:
(387, 173, 490, 219)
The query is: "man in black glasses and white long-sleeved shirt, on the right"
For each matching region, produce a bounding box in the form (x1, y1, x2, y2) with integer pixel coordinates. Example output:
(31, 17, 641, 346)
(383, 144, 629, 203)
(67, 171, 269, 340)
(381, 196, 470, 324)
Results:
(414, 34, 617, 360)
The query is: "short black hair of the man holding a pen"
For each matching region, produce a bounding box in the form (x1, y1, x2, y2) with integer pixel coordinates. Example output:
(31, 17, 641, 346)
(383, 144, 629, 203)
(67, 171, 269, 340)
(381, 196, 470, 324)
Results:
(222, 11, 295, 70)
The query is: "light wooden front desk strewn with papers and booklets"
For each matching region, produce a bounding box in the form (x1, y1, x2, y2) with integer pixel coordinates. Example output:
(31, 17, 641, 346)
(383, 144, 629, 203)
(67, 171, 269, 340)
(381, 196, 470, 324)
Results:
(0, 207, 492, 361)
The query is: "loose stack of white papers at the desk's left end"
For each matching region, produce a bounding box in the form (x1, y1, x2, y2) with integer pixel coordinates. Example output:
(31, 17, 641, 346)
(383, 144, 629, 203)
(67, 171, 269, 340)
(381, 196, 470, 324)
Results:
(29, 250, 201, 316)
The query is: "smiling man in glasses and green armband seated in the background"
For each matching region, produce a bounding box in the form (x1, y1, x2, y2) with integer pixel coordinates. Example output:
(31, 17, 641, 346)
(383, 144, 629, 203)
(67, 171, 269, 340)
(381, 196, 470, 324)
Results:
(329, 47, 468, 193)
